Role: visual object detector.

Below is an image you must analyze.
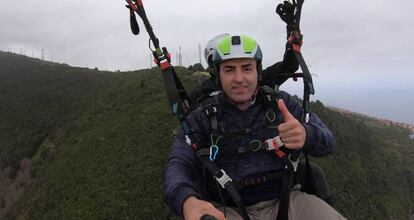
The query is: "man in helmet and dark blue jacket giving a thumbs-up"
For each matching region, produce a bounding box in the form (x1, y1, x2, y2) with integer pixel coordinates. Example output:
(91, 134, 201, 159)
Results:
(164, 35, 344, 220)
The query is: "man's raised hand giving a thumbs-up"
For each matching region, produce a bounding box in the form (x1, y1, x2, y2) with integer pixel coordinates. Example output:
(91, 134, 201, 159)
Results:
(277, 99, 306, 150)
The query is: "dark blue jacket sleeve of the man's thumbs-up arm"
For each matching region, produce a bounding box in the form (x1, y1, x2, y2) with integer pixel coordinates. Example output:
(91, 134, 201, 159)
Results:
(281, 91, 335, 157)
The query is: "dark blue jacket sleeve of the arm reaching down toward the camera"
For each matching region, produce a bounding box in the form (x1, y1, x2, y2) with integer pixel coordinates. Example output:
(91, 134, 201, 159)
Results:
(164, 110, 205, 217)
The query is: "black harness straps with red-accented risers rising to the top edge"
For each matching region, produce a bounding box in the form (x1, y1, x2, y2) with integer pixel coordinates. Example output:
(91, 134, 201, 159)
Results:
(126, 0, 332, 220)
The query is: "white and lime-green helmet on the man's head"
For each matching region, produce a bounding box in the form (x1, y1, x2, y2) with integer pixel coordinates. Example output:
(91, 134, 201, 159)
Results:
(213, 35, 263, 66)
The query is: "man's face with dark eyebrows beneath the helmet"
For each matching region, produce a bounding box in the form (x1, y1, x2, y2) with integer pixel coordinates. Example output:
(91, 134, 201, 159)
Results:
(220, 58, 258, 104)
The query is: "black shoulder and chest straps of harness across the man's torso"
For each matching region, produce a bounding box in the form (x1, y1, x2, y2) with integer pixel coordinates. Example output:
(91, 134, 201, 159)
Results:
(196, 86, 299, 214)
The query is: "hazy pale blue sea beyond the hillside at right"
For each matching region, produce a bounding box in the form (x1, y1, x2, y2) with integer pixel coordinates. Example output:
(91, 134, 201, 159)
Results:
(280, 73, 414, 125)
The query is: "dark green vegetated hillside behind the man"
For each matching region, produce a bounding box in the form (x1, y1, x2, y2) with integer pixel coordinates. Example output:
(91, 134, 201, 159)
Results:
(0, 52, 414, 219)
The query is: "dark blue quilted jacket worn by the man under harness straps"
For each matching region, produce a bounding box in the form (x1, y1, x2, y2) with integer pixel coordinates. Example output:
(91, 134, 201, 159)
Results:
(164, 89, 335, 216)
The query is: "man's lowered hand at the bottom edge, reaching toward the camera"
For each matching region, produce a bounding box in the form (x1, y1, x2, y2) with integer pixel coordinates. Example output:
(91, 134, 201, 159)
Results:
(183, 196, 225, 220)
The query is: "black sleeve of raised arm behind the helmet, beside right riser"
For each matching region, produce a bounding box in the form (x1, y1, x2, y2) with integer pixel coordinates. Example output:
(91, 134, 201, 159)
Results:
(262, 44, 299, 88)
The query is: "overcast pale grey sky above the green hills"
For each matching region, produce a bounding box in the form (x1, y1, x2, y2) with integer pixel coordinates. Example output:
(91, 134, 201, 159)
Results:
(0, 0, 414, 124)
